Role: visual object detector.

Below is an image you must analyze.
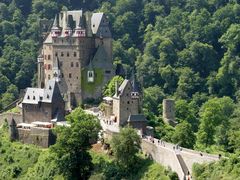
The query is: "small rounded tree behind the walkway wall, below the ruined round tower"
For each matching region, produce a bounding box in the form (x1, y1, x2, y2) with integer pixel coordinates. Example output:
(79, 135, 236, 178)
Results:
(172, 121, 195, 148)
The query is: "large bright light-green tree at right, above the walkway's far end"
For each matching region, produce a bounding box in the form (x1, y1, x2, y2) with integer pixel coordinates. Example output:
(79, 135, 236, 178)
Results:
(197, 97, 234, 148)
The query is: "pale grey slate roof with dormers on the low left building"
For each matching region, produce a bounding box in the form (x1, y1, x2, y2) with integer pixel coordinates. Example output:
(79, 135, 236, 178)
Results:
(22, 80, 57, 104)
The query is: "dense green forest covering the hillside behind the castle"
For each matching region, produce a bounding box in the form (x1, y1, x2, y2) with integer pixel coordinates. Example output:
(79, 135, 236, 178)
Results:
(0, 0, 240, 179)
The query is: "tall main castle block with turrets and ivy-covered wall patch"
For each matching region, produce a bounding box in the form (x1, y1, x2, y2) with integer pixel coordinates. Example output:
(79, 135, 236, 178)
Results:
(38, 10, 115, 110)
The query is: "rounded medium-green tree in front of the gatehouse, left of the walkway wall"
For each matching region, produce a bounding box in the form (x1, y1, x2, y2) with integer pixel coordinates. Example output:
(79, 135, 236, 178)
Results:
(110, 127, 141, 171)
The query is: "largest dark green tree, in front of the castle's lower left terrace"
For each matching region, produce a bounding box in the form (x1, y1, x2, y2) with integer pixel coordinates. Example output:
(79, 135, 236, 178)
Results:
(50, 108, 100, 179)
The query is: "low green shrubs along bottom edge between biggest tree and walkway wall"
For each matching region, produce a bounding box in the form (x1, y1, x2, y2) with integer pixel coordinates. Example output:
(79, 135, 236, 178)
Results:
(89, 150, 175, 180)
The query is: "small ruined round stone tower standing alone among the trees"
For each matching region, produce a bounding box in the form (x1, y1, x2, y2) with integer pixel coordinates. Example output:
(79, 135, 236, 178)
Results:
(163, 99, 176, 126)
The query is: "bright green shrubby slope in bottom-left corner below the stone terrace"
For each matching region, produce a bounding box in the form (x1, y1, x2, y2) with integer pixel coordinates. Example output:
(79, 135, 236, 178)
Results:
(0, 128, 41, 179)
